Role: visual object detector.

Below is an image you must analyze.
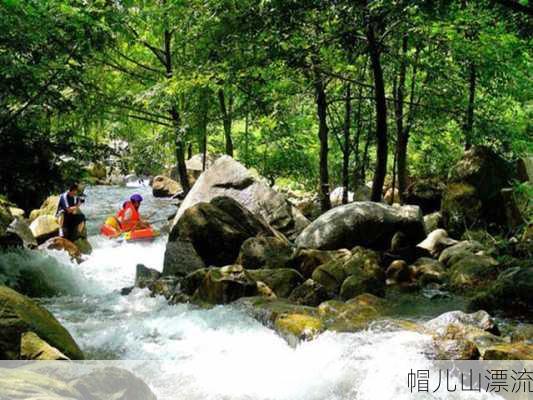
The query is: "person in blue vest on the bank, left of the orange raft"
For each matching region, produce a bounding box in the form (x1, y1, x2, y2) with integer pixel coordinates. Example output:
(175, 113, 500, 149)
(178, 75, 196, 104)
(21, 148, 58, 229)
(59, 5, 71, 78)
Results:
(56, 183, 85, 241)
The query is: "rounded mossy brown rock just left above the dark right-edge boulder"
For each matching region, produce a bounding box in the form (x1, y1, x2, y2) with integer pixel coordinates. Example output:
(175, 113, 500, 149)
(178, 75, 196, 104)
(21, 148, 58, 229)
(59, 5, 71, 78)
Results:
(449, 254, 500, 291)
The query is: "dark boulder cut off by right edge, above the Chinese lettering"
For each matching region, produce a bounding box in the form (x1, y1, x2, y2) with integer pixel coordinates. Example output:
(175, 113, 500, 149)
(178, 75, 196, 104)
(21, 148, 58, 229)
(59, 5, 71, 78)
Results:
(468, 267, 533, 315)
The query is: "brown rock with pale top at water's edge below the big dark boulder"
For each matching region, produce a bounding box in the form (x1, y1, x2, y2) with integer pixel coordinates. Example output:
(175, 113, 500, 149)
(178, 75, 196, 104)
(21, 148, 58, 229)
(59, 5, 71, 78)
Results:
(194, 265, 257, 304)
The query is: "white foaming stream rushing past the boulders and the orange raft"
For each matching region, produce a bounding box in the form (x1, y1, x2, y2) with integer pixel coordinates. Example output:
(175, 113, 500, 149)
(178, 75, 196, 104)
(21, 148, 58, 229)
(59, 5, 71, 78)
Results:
(0, 186, 502, 400)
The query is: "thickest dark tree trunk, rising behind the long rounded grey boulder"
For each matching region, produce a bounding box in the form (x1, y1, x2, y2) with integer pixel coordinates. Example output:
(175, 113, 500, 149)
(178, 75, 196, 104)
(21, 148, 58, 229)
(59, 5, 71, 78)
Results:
(367, 22, 388, 201)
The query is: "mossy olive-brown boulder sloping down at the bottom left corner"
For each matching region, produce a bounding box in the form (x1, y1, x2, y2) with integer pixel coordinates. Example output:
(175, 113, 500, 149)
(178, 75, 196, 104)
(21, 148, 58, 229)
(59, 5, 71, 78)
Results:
(0, 286, 83, 360)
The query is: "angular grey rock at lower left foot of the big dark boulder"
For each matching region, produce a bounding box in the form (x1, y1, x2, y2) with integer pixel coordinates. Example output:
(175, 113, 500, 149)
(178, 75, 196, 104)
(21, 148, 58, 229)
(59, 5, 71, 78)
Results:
(162, 239, 205, 276)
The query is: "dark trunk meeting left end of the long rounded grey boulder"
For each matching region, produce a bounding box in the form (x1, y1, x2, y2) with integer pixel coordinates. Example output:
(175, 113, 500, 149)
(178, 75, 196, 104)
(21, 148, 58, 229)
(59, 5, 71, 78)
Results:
(314, 71, 331, 212)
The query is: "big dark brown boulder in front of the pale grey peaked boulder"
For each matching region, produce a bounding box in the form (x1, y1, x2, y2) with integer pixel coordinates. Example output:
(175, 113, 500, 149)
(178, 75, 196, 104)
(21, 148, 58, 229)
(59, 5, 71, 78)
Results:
(164, 197, 276, 273)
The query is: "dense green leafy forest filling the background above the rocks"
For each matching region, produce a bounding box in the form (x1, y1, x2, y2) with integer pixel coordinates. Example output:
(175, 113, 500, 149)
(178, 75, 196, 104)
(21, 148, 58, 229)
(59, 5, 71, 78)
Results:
(0, 0, 533, 209)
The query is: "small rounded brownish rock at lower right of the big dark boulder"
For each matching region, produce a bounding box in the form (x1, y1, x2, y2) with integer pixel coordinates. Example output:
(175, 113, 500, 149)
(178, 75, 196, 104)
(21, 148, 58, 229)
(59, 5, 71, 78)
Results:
(237, 236, 292, 269)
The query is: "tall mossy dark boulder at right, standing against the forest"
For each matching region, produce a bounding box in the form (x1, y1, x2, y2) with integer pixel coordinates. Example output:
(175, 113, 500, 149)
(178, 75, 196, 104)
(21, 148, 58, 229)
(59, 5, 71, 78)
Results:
(442, 146, 512, 236)
